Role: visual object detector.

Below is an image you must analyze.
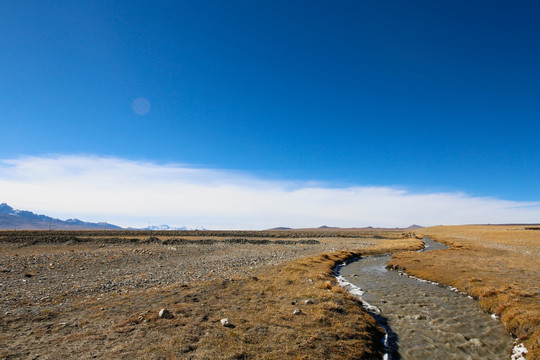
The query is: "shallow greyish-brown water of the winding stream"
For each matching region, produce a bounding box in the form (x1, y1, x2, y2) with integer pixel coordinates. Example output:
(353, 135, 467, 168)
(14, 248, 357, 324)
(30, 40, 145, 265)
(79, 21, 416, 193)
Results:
(339, 239, 513, 360)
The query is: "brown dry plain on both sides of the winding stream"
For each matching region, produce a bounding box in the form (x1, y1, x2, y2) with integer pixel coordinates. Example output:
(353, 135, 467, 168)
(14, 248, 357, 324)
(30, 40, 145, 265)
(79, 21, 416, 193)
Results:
(0, 226, 540, 360)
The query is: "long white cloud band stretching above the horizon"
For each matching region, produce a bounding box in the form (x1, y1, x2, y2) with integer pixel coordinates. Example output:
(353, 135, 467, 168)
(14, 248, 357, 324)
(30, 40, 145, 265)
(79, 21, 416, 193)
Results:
(0, 155, 540, 229)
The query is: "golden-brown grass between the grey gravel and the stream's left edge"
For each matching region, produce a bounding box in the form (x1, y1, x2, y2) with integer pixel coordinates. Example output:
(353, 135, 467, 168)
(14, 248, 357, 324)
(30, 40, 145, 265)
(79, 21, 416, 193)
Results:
(102, 239, 420, 359)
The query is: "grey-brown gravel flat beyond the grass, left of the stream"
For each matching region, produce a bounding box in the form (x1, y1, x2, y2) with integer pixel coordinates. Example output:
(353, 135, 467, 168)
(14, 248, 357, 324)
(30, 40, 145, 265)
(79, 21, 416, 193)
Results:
(0, 239, 376, 315)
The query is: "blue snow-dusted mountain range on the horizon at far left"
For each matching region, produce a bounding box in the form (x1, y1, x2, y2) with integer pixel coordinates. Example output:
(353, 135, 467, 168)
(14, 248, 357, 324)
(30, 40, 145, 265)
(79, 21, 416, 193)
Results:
(0, 203, 122, 230)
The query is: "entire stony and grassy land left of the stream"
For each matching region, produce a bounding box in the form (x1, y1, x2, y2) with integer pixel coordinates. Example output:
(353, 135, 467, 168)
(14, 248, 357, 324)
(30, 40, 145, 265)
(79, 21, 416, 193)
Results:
(0, 231, 421, 359)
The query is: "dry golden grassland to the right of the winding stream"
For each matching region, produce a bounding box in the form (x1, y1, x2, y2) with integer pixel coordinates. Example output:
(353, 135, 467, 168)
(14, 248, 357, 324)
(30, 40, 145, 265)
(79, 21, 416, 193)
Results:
(389, 225, 540, 359)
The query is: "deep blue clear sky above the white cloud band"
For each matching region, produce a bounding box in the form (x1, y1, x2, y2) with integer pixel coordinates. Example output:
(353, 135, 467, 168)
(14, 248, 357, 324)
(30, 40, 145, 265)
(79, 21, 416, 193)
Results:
(0, 0, 540, 201)
